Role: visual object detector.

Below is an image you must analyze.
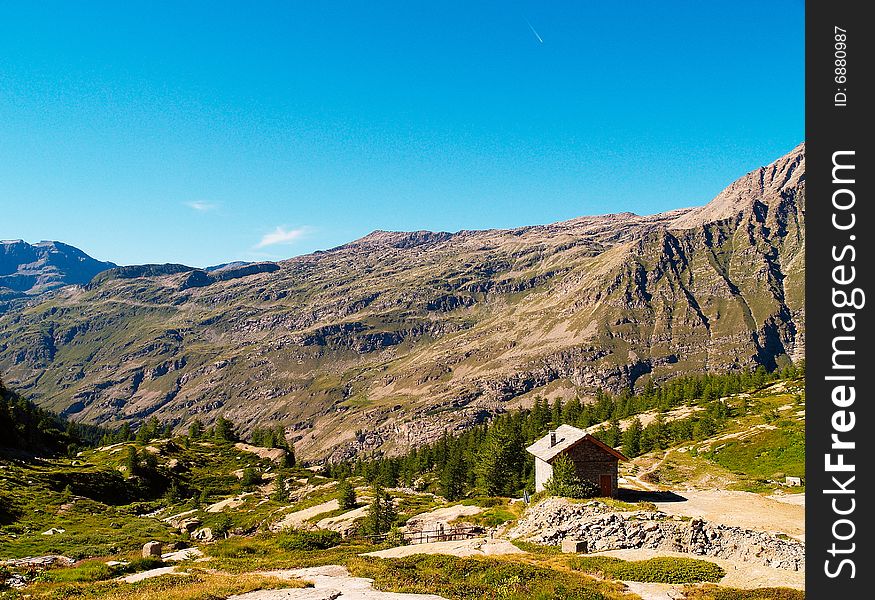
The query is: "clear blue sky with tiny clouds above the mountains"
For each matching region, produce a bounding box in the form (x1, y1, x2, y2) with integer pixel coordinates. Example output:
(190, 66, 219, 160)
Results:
(0, 0, 804, 266)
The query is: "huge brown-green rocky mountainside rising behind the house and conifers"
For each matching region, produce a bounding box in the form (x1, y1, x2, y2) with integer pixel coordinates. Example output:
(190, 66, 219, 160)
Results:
(0, 146, 805, 457)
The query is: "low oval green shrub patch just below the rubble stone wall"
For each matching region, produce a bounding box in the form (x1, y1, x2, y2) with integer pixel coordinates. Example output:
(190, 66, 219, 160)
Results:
(570, 556, 726, 583)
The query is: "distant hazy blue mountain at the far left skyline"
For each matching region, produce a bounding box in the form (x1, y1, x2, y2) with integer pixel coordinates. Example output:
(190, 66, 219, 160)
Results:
(0, 240, 115, 301)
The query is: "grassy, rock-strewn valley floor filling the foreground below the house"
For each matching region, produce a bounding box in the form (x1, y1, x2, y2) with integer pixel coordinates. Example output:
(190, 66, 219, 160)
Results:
(0, 378, 804, 600)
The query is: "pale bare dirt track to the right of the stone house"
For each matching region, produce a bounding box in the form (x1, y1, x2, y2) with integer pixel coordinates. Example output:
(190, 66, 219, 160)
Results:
(654, 490, 805, 540)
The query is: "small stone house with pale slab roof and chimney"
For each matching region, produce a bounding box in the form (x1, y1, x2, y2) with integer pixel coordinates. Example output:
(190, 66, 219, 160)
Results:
(526, 425, 629, 496)
